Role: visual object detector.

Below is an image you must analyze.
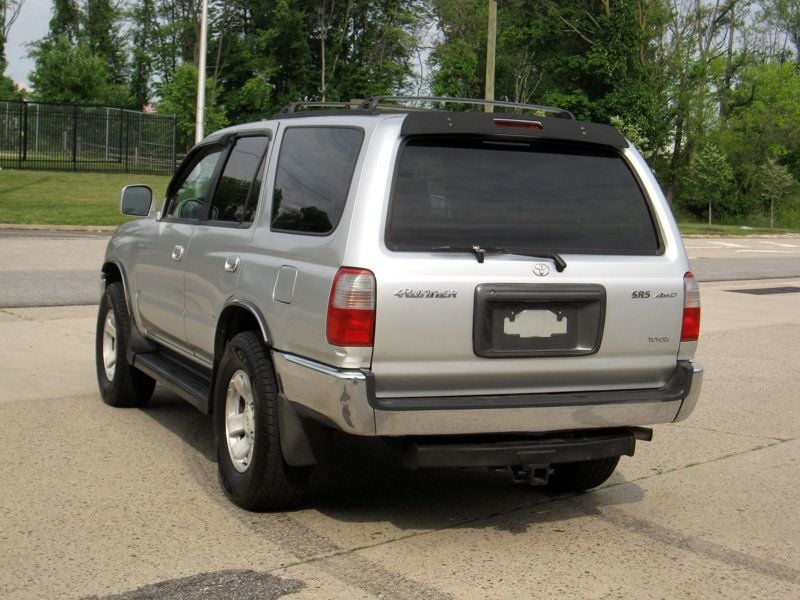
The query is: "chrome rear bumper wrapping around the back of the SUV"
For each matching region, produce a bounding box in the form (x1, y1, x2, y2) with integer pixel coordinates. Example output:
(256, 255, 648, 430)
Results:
(273, 352, 703, 436)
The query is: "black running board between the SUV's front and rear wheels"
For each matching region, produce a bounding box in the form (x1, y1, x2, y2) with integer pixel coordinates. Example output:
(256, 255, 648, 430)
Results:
(128, 348, 211, 414)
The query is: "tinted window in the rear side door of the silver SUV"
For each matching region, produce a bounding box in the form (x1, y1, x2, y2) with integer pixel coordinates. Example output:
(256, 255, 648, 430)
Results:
(208, 136, 269, 223)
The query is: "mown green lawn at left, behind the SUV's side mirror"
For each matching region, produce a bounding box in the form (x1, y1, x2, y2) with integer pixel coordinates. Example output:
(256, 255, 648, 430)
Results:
(0, 169, 170, 225)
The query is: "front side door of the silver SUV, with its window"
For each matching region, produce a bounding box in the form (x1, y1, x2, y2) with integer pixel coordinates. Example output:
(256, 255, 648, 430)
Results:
(134, 143, 225, 349)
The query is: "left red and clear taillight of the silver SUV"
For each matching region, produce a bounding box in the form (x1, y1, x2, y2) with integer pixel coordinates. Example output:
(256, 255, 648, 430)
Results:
(325, 267, 375, 346)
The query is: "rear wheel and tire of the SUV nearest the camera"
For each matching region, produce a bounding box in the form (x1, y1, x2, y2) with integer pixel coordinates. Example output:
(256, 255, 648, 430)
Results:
(213, 331, 311, 511)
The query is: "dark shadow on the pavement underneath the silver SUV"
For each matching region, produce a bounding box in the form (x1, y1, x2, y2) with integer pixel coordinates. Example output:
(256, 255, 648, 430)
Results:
(143, 388, 643, 533)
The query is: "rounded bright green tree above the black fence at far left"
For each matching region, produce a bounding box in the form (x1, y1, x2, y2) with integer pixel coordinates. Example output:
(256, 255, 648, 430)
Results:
(30, 36, 129, 106)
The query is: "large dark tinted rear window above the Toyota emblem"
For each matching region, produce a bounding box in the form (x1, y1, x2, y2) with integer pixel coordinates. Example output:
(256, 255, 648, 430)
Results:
(386, 139, 659, 255)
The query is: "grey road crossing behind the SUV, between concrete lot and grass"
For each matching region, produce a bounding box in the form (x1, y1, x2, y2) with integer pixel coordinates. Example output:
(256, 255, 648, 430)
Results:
(0, 230, 800, 308)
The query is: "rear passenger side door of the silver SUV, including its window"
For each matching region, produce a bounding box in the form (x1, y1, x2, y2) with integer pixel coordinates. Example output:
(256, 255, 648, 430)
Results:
(184, 131, 270, 362)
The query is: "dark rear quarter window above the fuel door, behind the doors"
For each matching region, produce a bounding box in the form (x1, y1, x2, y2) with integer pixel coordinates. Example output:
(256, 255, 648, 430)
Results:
(272, 127, 364, 234)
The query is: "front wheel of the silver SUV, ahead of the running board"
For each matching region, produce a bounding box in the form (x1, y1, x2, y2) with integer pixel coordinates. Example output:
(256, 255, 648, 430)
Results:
(95, 282, 156, 407)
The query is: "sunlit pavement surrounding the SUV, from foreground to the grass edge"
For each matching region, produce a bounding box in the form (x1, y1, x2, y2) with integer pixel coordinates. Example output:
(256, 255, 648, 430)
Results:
(0, 236, 800, 599)
